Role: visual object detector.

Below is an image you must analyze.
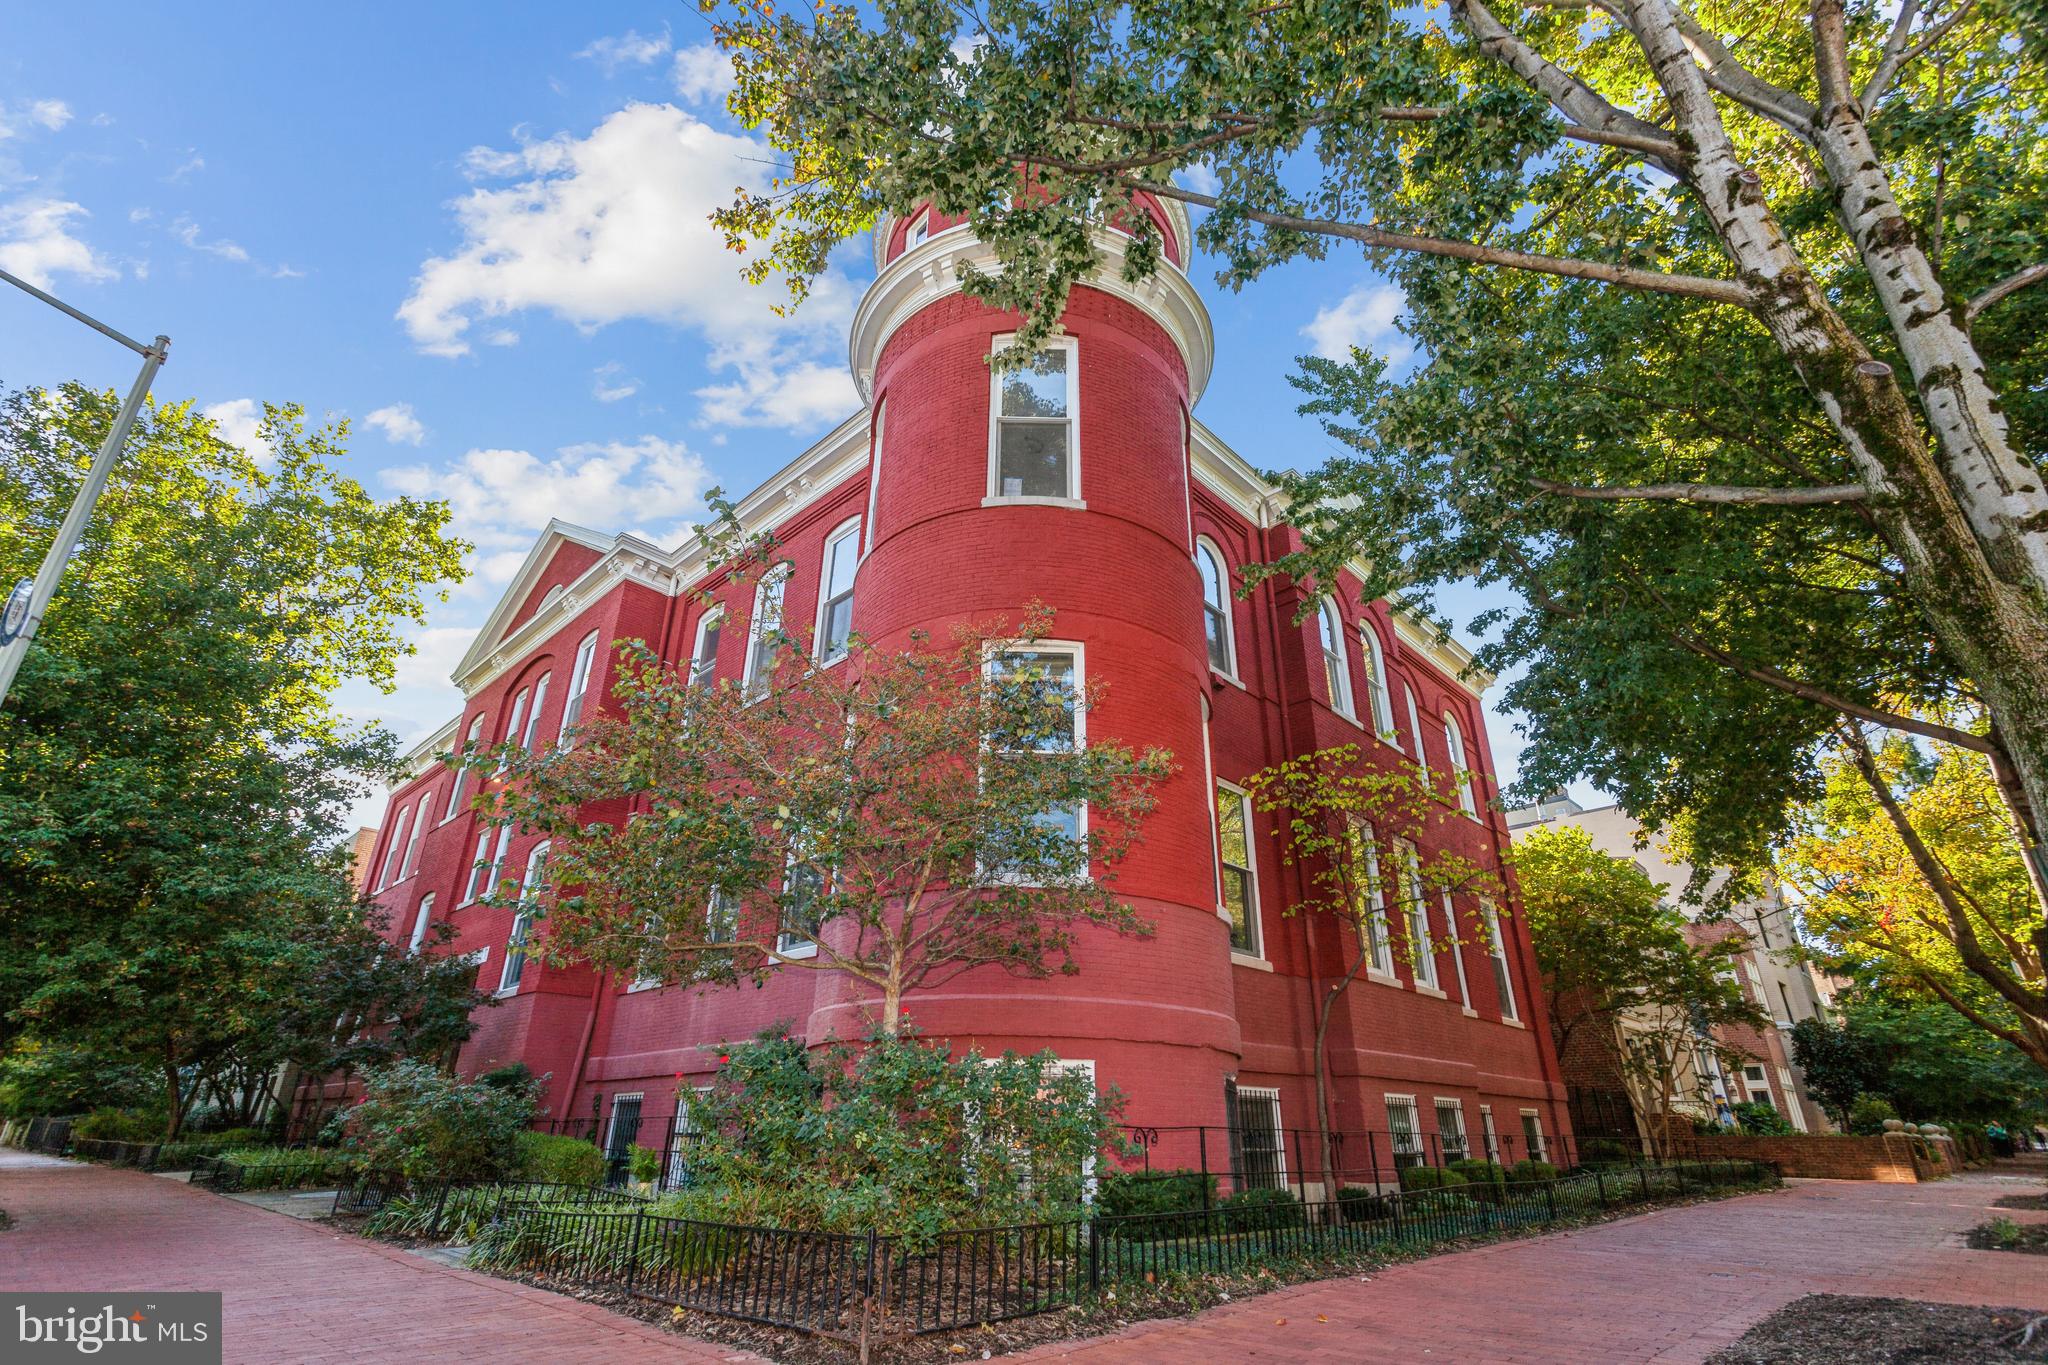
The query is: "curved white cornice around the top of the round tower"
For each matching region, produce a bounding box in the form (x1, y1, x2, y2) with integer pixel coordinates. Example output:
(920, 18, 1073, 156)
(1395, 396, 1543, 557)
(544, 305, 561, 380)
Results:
(846, 227, 1217, 403)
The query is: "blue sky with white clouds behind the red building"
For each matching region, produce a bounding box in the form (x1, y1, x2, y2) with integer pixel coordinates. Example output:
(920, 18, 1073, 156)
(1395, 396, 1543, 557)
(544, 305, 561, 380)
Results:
(0, 0, 1520, 822)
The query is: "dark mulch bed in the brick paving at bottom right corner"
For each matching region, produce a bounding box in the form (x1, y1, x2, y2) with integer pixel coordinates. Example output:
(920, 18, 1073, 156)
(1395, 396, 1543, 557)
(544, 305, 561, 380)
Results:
(1706, 1293, 2048, 1365)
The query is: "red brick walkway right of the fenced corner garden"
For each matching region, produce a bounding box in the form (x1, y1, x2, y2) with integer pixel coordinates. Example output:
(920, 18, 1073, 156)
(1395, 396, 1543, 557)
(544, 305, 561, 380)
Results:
(1014, 1175, 2048, 1365)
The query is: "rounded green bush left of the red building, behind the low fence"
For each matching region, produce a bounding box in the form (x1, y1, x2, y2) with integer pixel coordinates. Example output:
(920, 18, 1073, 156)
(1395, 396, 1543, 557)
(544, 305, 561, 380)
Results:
(344, 1062, 535, 1181)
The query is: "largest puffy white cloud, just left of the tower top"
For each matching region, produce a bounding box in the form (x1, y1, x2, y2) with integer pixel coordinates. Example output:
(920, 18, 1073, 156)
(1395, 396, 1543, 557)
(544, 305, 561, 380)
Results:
(397, 104, 854, 424)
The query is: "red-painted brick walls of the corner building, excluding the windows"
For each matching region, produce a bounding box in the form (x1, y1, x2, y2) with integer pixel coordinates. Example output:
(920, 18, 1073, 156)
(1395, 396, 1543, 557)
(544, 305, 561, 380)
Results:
(348, 202, 1569, 1162)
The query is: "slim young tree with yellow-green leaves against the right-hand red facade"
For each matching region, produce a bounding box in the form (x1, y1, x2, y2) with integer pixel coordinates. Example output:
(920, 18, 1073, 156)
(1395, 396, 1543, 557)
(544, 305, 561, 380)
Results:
(1245, 745, 1495, 1195)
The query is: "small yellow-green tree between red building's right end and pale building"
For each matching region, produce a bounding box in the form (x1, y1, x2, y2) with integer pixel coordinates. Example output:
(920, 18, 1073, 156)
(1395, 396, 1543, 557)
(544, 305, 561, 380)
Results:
(1513, 827, 1769, 1156)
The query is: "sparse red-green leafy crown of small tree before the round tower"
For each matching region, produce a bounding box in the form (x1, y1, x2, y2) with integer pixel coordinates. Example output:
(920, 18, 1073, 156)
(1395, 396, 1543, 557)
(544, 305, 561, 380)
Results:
(477, 609, 1171, 1033)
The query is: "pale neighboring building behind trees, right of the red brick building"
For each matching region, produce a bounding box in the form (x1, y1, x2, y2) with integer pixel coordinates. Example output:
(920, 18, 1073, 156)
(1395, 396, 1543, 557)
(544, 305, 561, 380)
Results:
(1507, 792, 1829, 1136)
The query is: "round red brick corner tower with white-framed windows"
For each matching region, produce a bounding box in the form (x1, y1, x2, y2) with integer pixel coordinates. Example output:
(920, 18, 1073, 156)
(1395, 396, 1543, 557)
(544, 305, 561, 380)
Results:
(809, 203, 1239, 1126)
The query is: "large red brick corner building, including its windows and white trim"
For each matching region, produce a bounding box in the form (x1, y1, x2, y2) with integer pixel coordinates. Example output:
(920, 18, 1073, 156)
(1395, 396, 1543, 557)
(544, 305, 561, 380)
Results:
(348, 207, 1565, 1185)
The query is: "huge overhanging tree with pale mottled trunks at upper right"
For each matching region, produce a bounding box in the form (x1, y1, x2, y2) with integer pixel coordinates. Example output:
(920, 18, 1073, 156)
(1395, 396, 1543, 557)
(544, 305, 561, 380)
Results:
(700, 0, 2048, 1023)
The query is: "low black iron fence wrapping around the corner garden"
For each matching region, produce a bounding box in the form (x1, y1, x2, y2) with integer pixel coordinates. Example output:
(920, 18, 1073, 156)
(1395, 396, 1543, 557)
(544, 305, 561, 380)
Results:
(383, 1160, 1769, 1338)
